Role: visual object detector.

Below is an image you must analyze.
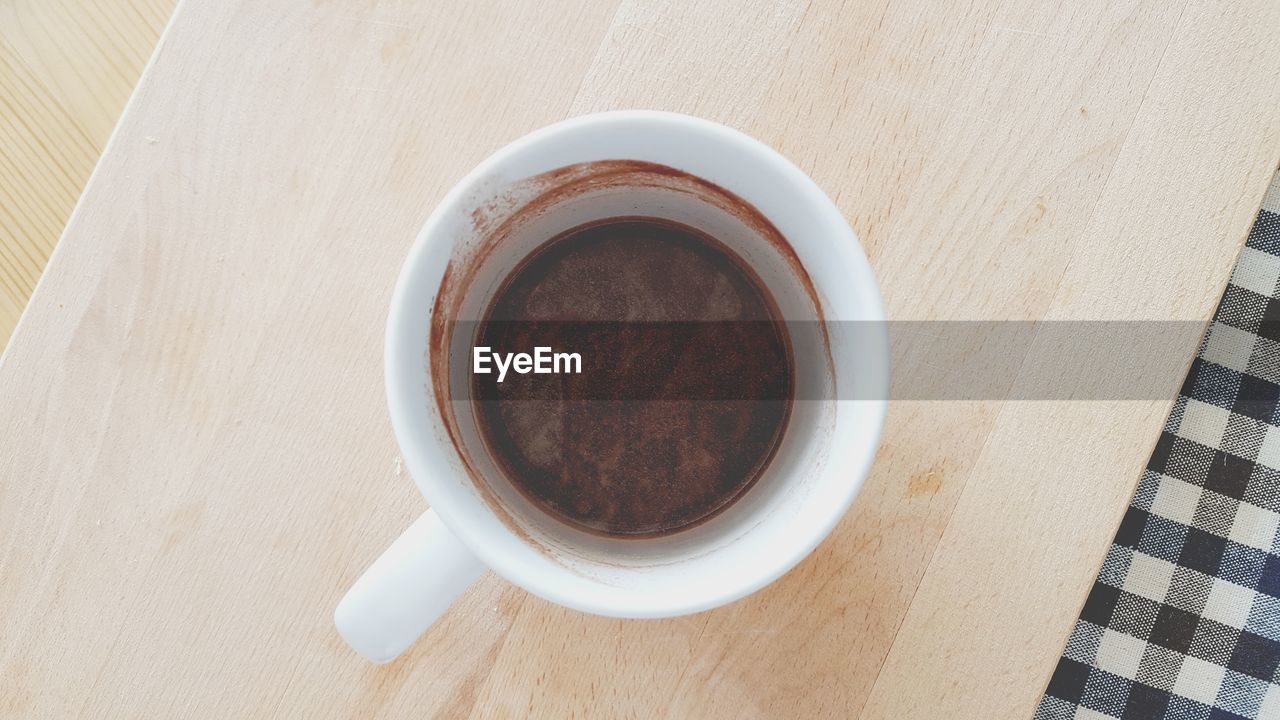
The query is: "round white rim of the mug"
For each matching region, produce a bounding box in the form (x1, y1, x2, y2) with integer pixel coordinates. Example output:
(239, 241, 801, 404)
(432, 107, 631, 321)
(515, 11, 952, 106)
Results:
(384, 110, 888, 618)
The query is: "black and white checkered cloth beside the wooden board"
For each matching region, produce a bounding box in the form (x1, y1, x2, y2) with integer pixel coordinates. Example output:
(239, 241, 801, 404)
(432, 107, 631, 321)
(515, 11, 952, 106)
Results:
(1036, 169, 1280, 720)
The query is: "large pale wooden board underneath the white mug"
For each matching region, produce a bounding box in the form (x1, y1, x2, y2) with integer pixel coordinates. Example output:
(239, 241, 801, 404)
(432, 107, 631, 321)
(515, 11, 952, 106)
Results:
(0, 0, 1280, 719)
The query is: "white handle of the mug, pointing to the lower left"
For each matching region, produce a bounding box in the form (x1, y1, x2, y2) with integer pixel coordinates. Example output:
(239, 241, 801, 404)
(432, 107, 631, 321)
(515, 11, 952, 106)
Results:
(333, 510, 485, 664)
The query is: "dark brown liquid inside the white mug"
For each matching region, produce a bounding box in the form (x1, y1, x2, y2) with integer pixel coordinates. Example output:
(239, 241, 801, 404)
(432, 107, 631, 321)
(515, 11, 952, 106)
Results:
(471, 219, 795, 537)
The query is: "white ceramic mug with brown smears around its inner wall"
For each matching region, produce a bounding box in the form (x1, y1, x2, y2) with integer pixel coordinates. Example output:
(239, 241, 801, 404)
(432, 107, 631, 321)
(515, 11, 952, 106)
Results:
(334, 110, 888, 662)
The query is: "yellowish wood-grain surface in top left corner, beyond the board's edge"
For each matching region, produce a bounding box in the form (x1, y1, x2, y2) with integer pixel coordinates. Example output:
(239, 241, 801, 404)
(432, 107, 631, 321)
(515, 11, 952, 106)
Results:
(0, 0, 175, 348)
